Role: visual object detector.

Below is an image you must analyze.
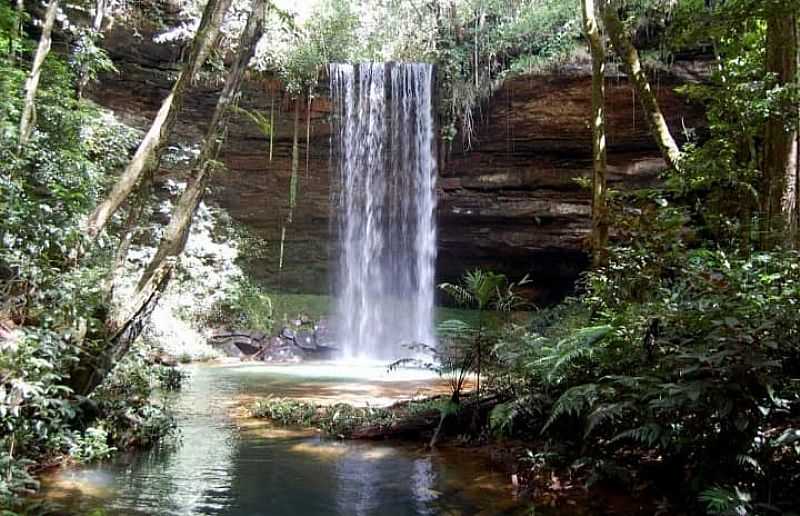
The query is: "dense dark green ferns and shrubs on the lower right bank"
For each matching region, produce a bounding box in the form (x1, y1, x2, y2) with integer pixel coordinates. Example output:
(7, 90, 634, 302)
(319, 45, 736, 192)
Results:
(492, 202, 800, 508)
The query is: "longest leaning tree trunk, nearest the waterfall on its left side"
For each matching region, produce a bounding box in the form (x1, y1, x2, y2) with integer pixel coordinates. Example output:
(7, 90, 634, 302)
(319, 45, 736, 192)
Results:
(71, 0, 267, 394)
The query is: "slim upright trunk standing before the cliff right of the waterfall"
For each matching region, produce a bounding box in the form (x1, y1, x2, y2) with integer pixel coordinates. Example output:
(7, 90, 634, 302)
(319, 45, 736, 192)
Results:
(581, 0, 608, 268)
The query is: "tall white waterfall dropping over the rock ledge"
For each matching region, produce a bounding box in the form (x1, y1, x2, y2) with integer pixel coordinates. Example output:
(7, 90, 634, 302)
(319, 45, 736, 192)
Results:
(330, 63, 436, 359)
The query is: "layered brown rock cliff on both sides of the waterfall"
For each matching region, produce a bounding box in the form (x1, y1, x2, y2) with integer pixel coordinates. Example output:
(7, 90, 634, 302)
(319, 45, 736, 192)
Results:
(91, 24, 702, 302)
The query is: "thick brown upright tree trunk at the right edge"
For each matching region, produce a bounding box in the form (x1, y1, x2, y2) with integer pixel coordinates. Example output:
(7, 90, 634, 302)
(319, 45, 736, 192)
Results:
(759, 7, 798, 249)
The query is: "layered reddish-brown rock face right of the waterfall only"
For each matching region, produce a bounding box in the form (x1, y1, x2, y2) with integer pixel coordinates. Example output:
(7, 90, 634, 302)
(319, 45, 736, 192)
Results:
(438, 66, 704, 302)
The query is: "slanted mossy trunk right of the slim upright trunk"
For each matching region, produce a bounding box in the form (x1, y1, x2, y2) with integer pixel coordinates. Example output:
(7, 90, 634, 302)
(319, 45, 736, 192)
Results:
(602, 4, 681, 170)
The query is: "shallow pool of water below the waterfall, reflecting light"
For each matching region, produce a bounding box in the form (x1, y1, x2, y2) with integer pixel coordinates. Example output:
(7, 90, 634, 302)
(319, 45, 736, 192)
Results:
(37, 365, 560, 516)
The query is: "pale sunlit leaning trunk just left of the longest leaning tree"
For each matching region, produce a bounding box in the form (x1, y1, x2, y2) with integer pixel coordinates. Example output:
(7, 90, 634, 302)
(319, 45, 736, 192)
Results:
(86, 0, 231, 238)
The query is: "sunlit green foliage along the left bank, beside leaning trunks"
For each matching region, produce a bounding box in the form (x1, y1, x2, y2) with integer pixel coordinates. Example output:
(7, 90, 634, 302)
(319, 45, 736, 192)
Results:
(0, 16, 176, 507)
